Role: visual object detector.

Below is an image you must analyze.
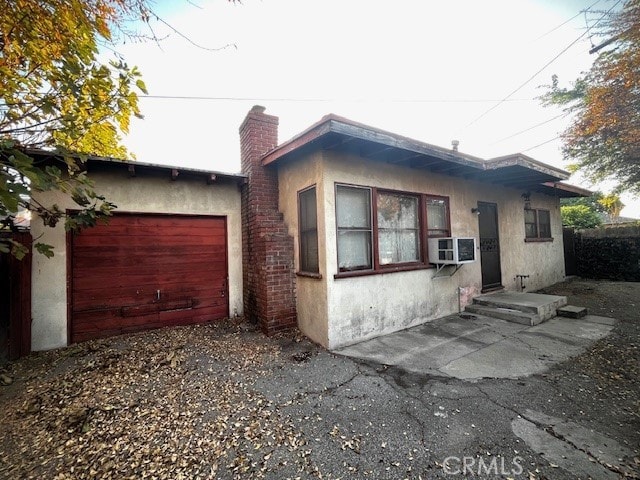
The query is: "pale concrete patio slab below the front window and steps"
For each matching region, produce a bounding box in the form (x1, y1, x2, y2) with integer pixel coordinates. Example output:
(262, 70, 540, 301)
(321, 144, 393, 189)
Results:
(334, 314, 616, 379)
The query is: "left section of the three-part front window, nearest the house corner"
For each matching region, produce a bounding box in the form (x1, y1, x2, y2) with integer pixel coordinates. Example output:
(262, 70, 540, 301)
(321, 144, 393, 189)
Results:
(336, 185, 373, 272)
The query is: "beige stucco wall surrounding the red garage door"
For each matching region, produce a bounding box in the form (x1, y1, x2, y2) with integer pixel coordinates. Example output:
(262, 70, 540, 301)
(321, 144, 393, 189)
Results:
(31, 170, 243, 350)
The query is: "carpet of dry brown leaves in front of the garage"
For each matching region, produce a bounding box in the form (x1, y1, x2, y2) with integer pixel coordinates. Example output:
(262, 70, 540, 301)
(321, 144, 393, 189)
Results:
(0, 325, 321, 480)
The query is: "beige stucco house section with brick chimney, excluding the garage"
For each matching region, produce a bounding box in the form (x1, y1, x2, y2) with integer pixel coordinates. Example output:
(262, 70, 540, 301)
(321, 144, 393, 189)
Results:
(241, 107, 589, 348)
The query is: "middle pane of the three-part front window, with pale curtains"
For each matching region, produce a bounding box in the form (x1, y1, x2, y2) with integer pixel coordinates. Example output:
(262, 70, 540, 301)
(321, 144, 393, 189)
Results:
(377, 193, 420, 265)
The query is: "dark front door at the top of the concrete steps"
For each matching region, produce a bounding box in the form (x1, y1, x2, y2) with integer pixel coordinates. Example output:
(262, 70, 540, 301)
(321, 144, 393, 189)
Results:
(478, 202, 503, 292)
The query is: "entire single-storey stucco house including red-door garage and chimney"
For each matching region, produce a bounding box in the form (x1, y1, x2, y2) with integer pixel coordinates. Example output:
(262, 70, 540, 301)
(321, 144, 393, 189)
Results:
(25, 106, 589, 350)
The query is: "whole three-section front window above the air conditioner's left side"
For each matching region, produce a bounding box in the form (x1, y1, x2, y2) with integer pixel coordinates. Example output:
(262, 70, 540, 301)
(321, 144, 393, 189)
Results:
(336, 184, 450, 275)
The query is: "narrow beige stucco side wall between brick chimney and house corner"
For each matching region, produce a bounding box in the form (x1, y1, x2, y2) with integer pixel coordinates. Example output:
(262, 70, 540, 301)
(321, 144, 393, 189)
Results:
(278, 153, 329, 345)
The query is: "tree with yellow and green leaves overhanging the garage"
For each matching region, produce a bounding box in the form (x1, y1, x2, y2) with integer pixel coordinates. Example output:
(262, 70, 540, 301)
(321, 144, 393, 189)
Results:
(0, 0, 151, 256)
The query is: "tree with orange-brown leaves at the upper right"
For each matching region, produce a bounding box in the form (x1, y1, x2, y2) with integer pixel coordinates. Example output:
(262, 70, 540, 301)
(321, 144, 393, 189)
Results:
(542, 0, 640, 194)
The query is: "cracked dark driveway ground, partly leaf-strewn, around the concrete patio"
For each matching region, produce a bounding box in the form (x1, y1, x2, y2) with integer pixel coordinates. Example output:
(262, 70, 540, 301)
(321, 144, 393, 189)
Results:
(0, 279, 640, 480)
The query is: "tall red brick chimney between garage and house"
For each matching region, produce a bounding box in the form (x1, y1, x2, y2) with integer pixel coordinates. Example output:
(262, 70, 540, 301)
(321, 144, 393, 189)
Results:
(240, 105, 297, 335)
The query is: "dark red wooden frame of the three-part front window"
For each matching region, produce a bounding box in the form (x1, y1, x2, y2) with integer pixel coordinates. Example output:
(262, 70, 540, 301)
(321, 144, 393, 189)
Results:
(334, 182, 451, 278)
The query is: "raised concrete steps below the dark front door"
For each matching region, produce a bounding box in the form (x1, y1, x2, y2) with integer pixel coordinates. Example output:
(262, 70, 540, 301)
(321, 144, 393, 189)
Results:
(473, 292, 567, 323)
